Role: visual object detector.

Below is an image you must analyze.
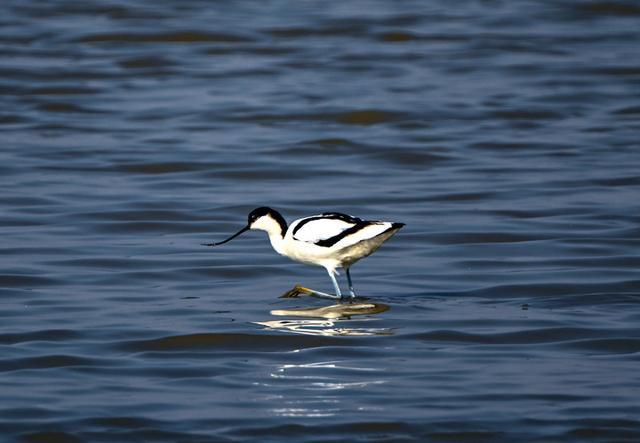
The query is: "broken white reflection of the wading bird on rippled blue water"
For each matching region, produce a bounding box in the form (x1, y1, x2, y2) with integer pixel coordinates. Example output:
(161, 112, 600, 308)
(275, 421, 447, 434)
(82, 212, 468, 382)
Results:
(255, 303, 393, 418)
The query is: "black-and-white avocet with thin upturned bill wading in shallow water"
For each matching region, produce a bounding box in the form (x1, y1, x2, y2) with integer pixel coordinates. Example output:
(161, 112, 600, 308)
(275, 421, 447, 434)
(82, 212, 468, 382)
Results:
(202, 206, 405, 300)
